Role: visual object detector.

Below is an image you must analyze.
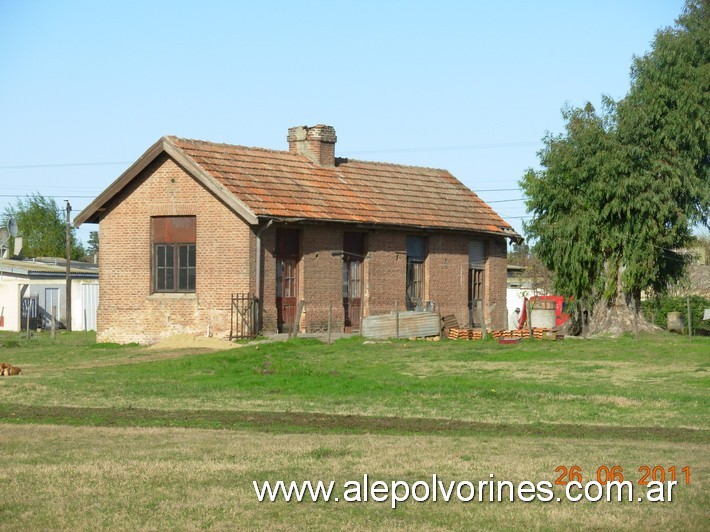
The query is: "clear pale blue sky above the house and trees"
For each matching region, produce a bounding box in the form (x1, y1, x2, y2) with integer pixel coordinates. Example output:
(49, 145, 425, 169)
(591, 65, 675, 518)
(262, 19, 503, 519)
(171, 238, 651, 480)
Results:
(0, 0, 683, 242)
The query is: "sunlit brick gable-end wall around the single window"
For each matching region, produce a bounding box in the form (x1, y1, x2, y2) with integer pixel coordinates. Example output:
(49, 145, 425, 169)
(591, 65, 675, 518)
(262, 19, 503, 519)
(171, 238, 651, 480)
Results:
(97, 154, 253, 343)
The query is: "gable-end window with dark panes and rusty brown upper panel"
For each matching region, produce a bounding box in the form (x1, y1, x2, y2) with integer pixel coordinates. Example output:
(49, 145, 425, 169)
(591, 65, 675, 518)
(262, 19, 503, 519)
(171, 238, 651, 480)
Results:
(151, 216, 197, 292)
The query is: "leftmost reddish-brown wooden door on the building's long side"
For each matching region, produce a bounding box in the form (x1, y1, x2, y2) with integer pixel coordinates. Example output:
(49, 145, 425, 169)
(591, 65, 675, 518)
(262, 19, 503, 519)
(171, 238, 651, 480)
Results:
(276, 229, 300, 332)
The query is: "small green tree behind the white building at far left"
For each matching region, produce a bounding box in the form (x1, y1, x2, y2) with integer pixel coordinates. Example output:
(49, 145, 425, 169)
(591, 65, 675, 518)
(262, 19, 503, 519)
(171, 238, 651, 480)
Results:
(4, 193, 85, 260)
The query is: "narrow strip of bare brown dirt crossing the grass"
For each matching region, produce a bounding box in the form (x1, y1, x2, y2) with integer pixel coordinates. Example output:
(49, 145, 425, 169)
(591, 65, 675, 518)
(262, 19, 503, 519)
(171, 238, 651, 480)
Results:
(0, 404, 710, 443)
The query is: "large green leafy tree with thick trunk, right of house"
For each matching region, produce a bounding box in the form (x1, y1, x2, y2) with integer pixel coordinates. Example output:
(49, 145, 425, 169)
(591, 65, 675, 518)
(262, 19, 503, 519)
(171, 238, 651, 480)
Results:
(521, 0, 710, 331)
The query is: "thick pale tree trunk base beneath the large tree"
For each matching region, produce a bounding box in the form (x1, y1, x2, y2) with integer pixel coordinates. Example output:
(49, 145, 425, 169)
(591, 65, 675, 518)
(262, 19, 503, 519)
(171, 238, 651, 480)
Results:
(589, 293, 661, 336)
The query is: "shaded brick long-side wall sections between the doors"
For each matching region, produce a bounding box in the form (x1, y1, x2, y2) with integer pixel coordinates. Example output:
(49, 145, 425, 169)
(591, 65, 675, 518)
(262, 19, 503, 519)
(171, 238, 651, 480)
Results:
(262, 224, 506, 333)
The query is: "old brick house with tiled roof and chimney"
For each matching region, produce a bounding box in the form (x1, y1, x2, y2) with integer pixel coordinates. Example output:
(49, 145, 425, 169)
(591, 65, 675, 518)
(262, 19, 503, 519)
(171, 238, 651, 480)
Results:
(75, 125, 519, 343)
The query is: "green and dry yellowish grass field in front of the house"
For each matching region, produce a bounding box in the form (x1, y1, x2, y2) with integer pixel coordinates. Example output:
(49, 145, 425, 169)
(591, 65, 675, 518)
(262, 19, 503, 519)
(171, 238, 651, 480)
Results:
(0, 333, 710, 530)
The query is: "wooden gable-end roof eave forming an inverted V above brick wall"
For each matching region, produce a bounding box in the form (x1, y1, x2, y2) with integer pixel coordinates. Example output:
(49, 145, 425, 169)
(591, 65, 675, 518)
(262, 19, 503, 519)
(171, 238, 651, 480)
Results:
(74, 137, 258, 227)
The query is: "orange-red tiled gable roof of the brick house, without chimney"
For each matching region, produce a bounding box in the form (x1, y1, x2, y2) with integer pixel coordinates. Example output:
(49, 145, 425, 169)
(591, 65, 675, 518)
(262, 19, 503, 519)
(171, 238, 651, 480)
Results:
(75, 137, 520, 239)
